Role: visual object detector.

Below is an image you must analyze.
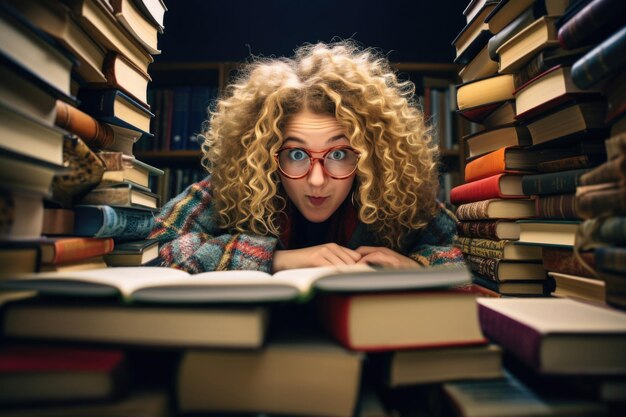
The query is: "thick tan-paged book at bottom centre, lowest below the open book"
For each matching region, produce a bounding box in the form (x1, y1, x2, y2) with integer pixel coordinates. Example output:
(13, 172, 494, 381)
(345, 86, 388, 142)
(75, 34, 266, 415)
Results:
(175, 339, 362, 417)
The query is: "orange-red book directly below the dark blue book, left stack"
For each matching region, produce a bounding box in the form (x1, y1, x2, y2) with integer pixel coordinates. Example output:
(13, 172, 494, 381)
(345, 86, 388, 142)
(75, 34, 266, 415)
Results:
(39, 237, 113, 265)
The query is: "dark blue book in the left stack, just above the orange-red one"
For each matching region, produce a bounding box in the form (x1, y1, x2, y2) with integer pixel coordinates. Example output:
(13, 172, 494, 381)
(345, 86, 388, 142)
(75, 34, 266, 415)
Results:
(74, 206, 154, 239)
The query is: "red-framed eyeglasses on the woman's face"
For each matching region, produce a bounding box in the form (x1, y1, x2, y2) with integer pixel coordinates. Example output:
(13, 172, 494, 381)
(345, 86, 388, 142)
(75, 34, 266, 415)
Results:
(274, 145, 361, 180)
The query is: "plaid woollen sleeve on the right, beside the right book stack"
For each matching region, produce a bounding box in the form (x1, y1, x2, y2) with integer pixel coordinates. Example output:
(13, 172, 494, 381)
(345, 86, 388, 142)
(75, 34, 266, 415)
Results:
(409, 203, 465, 266)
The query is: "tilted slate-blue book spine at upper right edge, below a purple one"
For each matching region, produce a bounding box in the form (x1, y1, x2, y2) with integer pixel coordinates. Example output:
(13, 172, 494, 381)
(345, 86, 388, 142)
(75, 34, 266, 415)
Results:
(571, 26, 626, 89)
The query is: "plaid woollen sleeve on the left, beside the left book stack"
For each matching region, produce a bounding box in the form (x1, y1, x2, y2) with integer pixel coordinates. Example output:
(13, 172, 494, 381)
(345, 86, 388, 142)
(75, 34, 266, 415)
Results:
(149, 178, 277, 274)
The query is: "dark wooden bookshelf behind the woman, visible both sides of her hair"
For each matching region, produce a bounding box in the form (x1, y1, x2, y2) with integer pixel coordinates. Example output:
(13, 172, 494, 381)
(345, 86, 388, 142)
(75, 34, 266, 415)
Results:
(135, 61, 468, 200)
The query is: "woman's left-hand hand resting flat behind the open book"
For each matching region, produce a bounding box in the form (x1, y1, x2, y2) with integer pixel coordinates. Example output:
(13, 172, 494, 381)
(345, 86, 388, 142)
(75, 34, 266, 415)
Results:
(272, 243, 361, 272)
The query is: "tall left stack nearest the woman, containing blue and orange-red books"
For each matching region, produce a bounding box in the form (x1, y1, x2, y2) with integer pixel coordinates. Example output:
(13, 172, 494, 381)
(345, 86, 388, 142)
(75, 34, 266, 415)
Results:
(7, 0, 166, 270)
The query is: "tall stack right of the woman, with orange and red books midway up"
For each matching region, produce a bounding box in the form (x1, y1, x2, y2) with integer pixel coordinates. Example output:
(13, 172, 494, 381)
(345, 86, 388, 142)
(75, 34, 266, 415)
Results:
(452, 1, 608, 301)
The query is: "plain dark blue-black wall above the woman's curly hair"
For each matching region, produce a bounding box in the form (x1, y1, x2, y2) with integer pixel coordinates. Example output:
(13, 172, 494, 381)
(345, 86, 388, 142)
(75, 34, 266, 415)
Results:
(156, 0, 469, 63)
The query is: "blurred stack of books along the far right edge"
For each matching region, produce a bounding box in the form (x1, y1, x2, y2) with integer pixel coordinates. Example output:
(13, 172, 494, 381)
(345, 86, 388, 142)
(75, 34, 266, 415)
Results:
(558, 0, 626, 308)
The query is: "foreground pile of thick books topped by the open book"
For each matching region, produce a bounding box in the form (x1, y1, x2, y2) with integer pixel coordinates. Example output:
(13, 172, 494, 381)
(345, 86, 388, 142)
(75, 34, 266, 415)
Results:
(0, 267, 502, 417)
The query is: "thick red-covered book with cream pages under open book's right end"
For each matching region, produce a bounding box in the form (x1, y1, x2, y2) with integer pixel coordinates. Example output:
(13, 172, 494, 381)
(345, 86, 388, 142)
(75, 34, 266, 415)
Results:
(320, 289, 486, 352)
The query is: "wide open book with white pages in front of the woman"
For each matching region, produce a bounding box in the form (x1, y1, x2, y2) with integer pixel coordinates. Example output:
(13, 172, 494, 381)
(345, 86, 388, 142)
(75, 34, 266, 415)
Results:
(0, 265, 471, 303)
